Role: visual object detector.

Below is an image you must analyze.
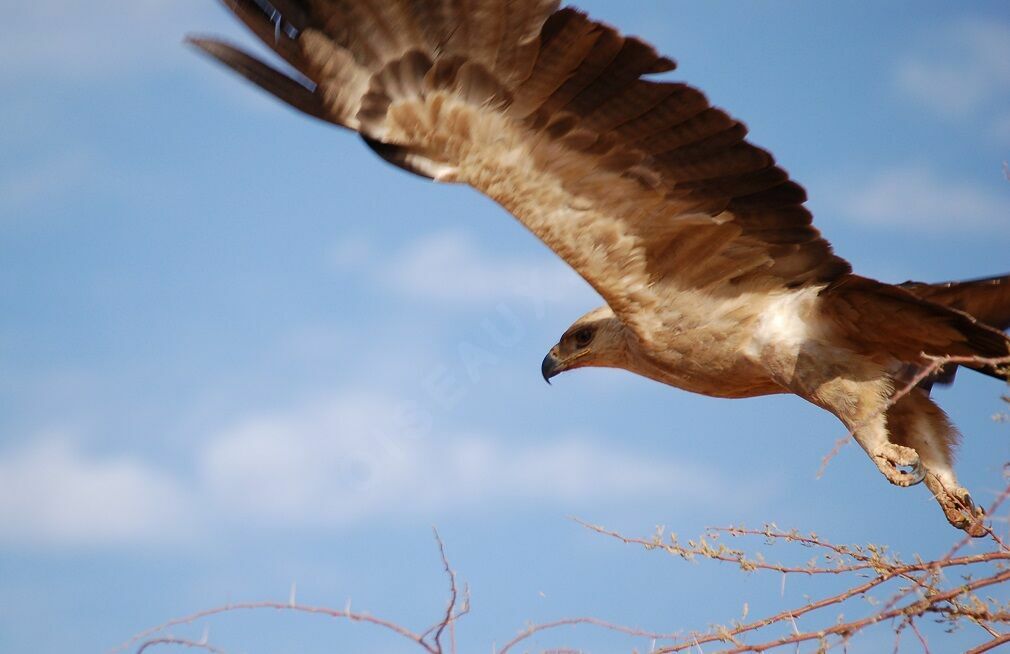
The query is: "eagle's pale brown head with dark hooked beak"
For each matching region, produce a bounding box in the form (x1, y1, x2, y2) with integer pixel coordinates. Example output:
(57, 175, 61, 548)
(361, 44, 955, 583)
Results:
(540, 306, 628, 384)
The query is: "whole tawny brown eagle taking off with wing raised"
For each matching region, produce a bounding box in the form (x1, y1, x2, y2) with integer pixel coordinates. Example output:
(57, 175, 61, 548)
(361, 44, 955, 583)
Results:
(191, 0, 1010, 534)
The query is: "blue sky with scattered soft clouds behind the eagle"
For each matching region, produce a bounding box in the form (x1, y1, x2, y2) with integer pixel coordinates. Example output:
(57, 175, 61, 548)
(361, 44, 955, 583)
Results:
(0, 0, 1010, 653)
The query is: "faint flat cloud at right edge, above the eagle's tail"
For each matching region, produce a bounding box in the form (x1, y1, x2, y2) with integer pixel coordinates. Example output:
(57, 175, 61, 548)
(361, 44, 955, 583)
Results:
(843, 165, 1010, 234)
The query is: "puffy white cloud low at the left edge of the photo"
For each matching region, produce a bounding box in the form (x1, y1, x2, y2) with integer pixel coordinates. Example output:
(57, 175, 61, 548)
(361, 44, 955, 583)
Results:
(0, 436, 191, 546)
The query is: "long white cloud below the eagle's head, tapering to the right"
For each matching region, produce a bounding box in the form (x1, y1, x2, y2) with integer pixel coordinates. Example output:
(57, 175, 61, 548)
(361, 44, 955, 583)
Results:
(200, 395, 717, 526)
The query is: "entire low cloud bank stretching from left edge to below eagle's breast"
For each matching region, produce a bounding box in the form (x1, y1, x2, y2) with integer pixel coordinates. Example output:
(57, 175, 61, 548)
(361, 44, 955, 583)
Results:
(0, 392, 715, 548)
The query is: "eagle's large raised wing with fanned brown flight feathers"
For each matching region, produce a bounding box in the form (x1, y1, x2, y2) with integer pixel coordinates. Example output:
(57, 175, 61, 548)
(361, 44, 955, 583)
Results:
(187, 0, 849, 340)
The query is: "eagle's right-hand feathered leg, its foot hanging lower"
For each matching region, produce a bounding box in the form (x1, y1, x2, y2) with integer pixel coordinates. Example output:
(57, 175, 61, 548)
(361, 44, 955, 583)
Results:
(887, 389, 985, 537)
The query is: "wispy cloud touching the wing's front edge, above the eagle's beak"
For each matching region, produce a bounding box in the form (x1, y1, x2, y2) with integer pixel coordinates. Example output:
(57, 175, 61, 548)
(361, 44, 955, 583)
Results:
(332, 231, 600, 309)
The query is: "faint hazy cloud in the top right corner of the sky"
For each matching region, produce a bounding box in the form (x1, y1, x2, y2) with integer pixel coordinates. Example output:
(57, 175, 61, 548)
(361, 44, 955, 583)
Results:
(895, 18, 1010, 118)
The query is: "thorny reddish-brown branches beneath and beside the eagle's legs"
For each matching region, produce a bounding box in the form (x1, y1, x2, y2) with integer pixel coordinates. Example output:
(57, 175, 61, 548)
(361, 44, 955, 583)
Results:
(120, 357, 1010, 654)
